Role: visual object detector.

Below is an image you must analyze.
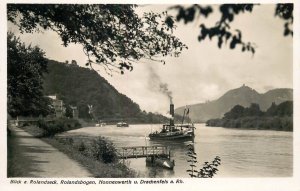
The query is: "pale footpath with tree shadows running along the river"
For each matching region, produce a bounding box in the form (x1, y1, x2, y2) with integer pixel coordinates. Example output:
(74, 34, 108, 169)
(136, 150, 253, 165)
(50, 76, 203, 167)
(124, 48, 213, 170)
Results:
(7, 127, 92, 178)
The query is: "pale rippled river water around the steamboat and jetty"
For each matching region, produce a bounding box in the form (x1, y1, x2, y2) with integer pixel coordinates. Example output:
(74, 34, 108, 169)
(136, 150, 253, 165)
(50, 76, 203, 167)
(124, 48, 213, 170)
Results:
(60, 124, 293, 177)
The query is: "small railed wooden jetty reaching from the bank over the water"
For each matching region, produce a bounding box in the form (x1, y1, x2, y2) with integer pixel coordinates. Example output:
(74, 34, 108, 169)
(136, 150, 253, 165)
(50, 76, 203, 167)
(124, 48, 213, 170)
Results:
(117, 146, 170, 159)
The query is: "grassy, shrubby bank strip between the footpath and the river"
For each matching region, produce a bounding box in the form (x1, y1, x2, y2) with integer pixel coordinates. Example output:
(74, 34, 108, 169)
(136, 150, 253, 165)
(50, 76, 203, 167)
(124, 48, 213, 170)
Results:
(23, 126, 137, 178)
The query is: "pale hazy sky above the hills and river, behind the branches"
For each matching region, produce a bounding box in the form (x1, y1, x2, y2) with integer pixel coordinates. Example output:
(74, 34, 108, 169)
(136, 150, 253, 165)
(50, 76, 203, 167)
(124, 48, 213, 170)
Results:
(9, 5, 293, 114)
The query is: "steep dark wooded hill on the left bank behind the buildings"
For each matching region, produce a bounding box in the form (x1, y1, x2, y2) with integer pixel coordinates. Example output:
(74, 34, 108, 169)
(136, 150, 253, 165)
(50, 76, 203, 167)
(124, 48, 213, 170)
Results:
(44, 60, 166, 122)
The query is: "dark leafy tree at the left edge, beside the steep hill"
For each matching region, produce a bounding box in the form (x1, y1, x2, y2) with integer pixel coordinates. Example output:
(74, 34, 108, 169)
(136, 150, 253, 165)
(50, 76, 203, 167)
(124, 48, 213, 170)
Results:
(7, 33, 52, 117)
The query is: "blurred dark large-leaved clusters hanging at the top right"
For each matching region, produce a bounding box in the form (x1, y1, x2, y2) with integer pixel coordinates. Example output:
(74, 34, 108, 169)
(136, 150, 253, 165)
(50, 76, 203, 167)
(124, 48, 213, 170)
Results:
(168, 3, 294, 54)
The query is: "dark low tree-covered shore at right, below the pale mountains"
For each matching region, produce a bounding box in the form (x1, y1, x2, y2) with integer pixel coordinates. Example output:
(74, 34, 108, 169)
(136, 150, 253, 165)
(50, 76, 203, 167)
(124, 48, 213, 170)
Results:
(206, 101, 293, 131)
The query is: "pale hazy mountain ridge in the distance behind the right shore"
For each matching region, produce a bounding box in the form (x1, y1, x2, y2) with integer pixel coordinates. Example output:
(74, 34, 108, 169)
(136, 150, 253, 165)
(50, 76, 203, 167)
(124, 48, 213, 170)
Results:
(175, 85, 293, 122)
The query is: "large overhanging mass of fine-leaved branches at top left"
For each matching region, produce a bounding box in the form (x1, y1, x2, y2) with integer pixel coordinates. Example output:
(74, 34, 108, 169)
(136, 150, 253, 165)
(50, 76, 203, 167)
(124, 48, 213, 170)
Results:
(7, 4, 187, 74)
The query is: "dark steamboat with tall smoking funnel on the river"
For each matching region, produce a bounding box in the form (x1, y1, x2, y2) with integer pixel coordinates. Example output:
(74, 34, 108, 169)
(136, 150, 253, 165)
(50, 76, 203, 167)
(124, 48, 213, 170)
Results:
(149, 104, 195, 140)
